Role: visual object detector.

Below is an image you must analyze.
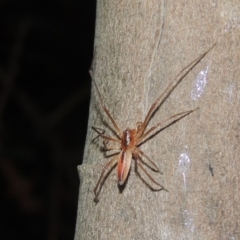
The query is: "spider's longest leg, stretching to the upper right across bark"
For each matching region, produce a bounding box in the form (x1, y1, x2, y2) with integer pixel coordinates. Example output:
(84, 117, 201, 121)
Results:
(139, 43, 216, 136)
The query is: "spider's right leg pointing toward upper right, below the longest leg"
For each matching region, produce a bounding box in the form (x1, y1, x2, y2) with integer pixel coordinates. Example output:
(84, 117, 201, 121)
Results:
(137, 108, 199, 145)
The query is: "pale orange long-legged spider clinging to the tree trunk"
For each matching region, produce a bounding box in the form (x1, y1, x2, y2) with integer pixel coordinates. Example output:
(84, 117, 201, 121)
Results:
(90, 44, 215, 202)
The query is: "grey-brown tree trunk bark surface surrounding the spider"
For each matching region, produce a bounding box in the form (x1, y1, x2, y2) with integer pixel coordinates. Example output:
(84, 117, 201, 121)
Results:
(75, 0, 240, 240)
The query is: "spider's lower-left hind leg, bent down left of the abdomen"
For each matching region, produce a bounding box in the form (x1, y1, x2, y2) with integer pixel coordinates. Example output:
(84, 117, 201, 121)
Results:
(94, 155, 118, 203)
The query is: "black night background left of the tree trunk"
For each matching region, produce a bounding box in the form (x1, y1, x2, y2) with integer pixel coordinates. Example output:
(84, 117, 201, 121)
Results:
(0, 0, 96, 240)
